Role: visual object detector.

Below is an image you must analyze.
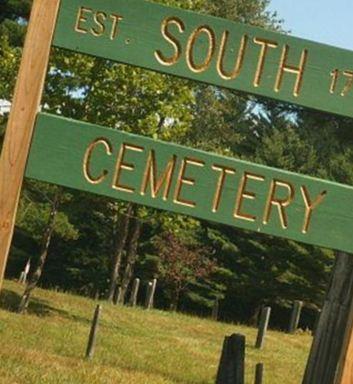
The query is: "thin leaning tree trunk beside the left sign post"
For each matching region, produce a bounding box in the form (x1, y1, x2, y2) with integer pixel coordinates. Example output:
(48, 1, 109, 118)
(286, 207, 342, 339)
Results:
(18, 192, 60, 313)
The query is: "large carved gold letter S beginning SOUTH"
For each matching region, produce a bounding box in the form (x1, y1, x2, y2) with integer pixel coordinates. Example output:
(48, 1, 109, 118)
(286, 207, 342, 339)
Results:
(154, 17, 185, 66)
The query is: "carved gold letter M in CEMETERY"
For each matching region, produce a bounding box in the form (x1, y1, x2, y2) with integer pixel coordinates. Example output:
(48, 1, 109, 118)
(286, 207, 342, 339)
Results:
(140, 150, 176, 200)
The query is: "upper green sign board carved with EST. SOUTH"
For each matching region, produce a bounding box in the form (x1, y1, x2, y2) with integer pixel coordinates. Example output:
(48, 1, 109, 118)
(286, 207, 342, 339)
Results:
(53, 0, 353, 117)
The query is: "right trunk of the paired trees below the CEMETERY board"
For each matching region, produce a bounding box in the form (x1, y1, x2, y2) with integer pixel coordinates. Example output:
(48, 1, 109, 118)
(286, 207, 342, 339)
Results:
(119, 213, 142, 304)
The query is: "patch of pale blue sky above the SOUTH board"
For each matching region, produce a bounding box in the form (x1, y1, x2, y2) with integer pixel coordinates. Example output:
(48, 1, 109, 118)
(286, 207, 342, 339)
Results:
(269, 0, 353, 50)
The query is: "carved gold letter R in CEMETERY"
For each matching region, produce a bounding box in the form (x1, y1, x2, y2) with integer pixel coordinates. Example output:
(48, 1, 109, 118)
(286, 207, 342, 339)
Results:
(263, 180, 295, 229)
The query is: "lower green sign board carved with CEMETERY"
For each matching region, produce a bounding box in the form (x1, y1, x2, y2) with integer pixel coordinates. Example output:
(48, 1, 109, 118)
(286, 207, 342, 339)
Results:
(26, 114, 353, 252)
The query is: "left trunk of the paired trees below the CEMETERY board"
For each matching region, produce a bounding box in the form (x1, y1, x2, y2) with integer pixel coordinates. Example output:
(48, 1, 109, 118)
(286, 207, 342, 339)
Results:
(107, 204, 132, 302)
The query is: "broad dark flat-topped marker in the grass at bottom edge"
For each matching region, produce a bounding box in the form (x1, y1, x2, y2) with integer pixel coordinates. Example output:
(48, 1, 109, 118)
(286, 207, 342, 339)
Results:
(216, 335, 245, 384)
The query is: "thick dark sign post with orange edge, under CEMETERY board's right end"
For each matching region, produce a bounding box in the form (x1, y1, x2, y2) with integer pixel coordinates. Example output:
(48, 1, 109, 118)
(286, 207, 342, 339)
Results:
(303, 253, 353, 384)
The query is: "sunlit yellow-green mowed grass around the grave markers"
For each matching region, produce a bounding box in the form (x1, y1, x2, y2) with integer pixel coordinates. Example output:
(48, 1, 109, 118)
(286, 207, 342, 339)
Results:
(0, 281, 312, 384)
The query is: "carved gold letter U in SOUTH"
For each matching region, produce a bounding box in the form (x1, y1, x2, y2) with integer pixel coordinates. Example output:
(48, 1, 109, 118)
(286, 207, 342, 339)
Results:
(217, 31, 248, 80)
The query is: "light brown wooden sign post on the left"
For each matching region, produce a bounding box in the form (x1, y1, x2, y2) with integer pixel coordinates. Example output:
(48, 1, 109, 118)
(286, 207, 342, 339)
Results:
(0, 0, 60, 290)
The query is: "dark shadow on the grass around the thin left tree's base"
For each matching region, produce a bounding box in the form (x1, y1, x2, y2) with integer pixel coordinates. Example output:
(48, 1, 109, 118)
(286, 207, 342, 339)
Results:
(0, 289, 90, 324)
